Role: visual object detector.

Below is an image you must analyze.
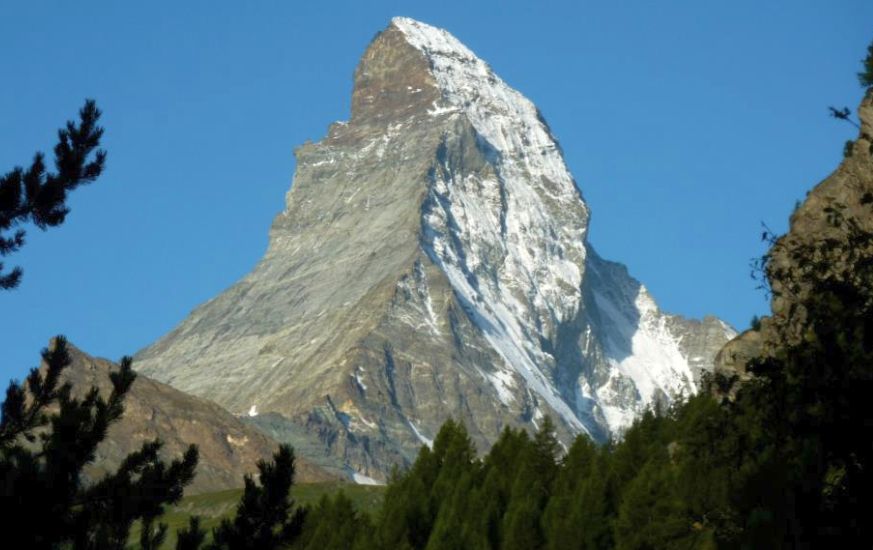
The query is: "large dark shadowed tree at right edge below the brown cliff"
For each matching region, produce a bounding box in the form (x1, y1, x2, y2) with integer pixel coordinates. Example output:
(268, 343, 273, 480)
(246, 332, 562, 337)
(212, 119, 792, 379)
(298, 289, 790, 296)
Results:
(739, 201, 873, 547)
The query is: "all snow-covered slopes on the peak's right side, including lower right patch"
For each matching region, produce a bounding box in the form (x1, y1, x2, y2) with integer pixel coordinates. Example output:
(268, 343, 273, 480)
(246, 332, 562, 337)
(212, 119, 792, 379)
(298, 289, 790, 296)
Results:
(392, 17, 730, 438)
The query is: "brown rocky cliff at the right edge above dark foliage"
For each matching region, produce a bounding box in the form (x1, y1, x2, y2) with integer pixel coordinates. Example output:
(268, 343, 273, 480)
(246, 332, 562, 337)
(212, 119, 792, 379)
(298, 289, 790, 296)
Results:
(716, 90, 873, 381)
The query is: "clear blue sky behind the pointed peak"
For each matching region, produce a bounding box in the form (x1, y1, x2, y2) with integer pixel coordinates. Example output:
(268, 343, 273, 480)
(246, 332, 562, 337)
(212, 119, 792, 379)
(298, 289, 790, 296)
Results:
(0, 0, 873, 380)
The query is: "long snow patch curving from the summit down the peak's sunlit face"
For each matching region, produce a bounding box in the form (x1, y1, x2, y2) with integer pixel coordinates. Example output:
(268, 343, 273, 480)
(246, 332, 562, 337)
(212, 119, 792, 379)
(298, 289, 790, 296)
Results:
(402, 18, 588, 431)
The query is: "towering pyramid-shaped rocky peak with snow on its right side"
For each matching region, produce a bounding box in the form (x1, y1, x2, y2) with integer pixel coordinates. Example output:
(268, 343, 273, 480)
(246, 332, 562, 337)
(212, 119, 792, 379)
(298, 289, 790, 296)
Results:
(136, 18, 734, 481)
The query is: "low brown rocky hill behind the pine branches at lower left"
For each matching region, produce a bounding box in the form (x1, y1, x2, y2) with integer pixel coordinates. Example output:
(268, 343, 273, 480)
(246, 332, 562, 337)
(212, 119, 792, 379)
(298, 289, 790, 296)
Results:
(63, 346, 337, 494)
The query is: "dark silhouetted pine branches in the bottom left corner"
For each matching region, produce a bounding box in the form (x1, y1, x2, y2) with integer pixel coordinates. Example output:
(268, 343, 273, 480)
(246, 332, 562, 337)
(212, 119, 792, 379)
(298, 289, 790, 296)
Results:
(0, 337, 198, 548)
